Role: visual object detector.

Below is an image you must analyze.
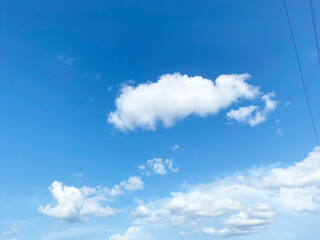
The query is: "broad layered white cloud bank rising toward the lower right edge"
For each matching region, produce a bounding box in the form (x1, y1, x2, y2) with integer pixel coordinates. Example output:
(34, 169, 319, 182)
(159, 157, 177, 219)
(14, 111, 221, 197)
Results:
(132, 149, 320, 236)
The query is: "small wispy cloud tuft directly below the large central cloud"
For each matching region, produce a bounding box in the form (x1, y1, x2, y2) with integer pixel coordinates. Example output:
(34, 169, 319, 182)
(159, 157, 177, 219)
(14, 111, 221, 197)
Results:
(139, 158, 179, 175)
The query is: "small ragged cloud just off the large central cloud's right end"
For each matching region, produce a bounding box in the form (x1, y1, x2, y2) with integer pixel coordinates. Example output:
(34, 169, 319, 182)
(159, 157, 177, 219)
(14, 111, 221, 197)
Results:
(227, 92, 277, 127)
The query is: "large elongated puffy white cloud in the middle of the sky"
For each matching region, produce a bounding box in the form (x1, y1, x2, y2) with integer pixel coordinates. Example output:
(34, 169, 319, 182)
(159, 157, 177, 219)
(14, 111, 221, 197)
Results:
(108, 73, 259, 131)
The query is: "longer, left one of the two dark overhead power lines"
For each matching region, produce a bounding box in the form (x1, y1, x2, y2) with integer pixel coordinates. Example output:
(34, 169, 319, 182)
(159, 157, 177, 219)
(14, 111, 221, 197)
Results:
(283, 0, 320, 148)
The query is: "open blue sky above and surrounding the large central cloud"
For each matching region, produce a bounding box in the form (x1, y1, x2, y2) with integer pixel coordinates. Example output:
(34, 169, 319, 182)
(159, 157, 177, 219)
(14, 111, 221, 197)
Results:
(0, 0, 320, 225)
